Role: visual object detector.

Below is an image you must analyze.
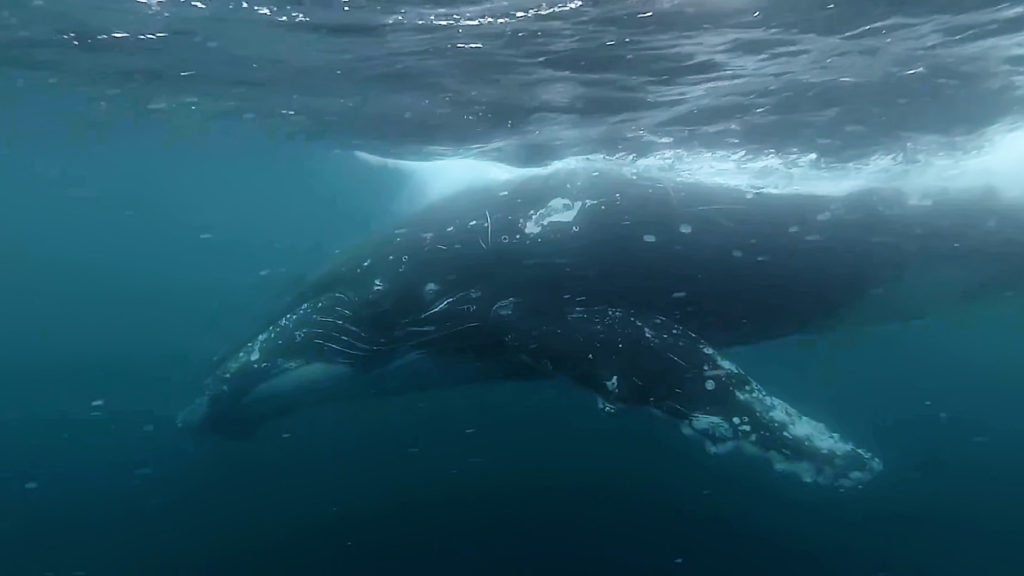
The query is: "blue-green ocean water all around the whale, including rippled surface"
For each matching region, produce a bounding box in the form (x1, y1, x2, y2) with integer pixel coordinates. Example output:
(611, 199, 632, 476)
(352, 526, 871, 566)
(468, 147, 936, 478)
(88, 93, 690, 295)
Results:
(0, 0, 1024, 576)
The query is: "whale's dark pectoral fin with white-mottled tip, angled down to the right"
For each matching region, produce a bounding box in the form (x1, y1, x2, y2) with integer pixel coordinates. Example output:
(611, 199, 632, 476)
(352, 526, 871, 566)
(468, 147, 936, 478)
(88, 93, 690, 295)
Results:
(493, 308, 882, 487)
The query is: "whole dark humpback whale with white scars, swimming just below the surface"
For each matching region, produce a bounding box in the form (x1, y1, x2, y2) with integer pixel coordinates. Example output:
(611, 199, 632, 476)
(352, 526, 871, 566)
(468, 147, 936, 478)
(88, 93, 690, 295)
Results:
(178, 174, 1024, 488)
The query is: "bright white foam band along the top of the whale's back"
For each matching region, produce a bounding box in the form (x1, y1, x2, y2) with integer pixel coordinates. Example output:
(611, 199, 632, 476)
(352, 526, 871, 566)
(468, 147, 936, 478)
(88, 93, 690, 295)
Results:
(356, 119, 1024, 202)
